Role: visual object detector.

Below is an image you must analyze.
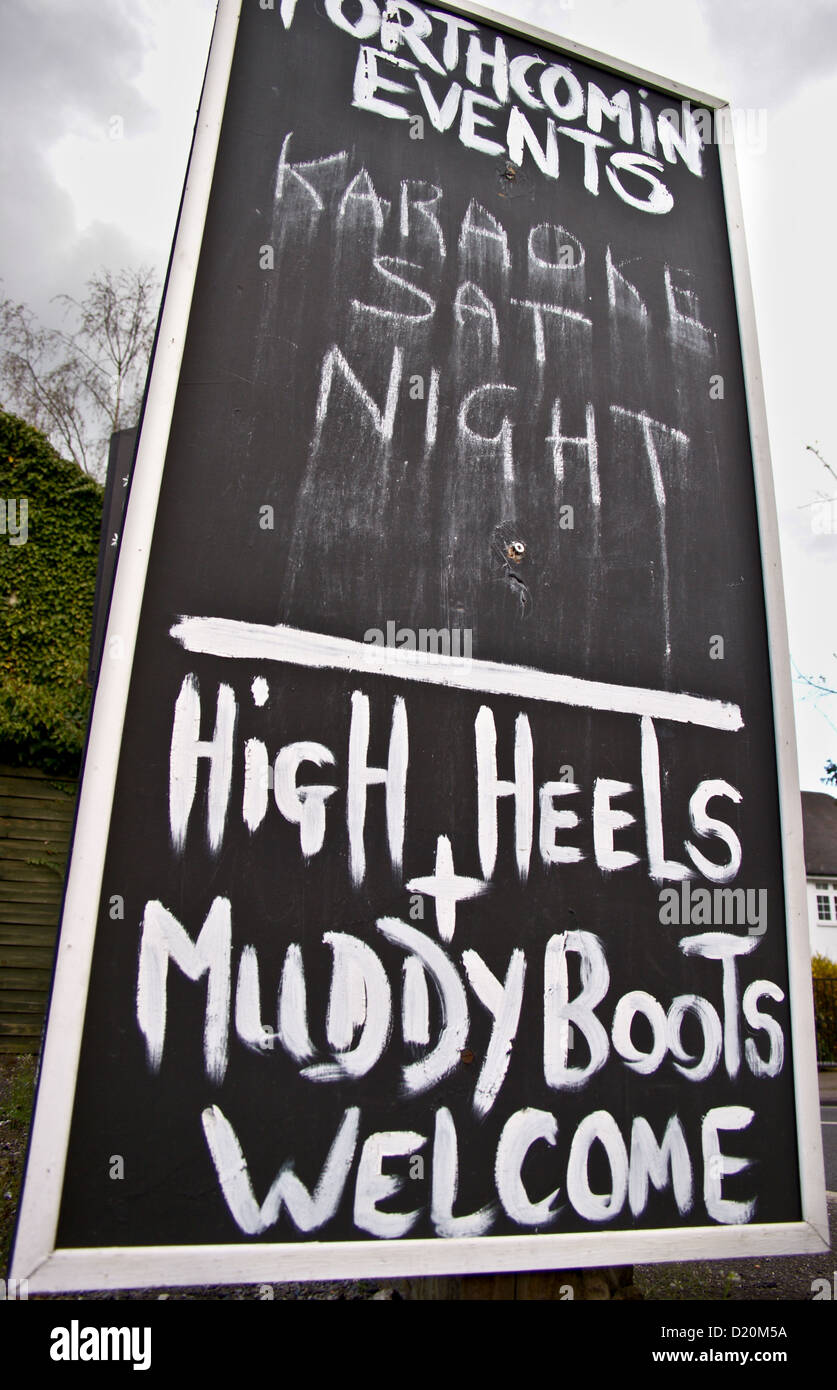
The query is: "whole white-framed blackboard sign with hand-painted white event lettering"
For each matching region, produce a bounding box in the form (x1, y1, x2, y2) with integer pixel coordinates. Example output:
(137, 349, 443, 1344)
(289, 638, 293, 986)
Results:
(14, 0, 824, 1289)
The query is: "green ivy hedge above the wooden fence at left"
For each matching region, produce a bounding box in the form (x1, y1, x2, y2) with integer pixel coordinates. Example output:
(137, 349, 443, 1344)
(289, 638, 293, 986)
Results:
(0, 411, 103, 774)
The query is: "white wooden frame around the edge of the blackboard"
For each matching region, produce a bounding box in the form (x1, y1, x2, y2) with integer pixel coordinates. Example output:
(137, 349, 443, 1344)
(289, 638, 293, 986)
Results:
(11, 0, 829, 1293)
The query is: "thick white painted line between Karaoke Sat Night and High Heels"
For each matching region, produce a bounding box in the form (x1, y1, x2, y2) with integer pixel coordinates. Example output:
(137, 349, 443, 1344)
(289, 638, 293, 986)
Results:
(171, 617, 744, 731)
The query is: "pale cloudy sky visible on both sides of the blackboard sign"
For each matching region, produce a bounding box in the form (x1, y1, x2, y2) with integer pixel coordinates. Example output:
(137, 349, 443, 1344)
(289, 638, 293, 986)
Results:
(0, 0, 837, 791)
